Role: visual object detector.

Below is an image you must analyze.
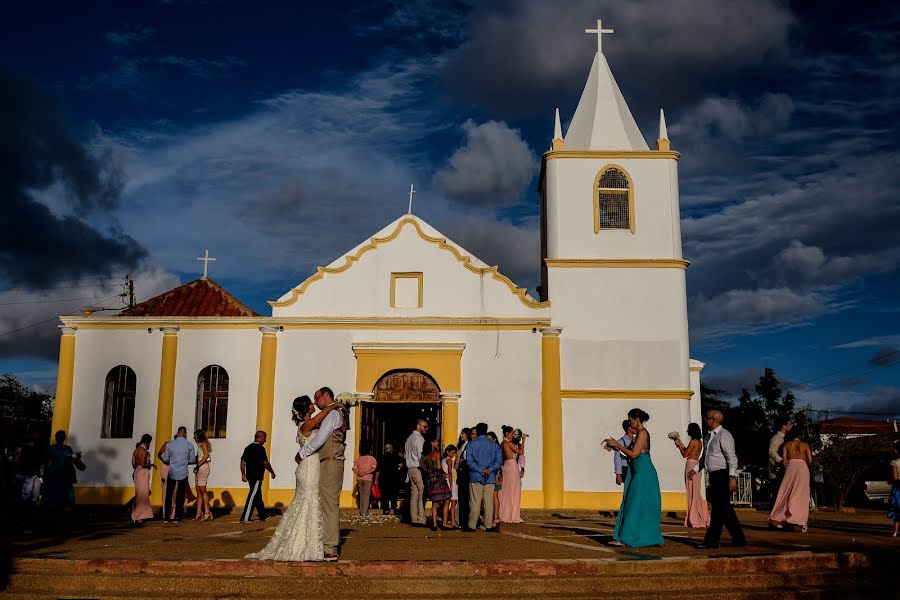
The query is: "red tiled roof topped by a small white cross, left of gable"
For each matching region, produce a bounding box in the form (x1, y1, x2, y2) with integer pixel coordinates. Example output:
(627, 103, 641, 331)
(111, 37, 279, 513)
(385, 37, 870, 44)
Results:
(119, 278, 259, 317)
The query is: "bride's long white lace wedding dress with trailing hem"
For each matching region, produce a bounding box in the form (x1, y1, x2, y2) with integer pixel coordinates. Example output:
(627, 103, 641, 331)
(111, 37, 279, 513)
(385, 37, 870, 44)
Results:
(246, 427, 324, 561)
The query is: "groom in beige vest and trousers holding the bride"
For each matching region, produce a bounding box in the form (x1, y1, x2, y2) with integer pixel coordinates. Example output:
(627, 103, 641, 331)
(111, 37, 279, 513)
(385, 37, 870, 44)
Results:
(297, 387, 347, 561)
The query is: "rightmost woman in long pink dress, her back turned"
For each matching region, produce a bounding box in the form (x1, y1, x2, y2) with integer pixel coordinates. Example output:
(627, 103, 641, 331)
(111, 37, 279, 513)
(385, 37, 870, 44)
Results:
(769, 428, 812, 532)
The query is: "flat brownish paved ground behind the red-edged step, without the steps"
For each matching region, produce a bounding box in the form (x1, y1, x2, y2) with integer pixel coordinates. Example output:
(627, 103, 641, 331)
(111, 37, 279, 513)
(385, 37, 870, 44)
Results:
(9, 507, 900, 561)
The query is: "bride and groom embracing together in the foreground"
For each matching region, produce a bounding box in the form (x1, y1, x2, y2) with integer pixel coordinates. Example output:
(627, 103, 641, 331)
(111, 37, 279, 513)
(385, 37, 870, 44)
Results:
(246, 387, 348, 561)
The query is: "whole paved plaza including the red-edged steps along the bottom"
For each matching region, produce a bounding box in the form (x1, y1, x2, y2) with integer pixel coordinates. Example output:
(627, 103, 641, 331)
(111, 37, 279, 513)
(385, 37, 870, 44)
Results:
(2, 507, 900, 599)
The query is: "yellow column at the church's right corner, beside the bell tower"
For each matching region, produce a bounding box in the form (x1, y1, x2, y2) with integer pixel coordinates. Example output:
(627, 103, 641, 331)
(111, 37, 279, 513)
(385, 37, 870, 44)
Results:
(541, 327, 563, 508)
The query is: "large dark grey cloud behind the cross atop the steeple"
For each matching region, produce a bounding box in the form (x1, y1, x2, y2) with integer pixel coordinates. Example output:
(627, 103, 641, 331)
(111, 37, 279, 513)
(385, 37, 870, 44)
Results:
(444, 0, 794, 119)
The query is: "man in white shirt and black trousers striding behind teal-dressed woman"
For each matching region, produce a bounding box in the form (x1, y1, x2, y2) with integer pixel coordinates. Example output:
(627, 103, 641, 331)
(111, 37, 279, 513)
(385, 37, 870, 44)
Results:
(688, 410, 747, 549)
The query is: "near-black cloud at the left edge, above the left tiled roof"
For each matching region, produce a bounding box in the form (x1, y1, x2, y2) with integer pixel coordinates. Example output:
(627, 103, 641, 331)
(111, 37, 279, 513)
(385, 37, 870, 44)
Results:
(0, 71, 146, 286)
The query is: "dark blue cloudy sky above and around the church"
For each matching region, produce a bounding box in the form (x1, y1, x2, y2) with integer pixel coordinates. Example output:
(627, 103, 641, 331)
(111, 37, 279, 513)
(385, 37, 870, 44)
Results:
(0, 0, 900, 419)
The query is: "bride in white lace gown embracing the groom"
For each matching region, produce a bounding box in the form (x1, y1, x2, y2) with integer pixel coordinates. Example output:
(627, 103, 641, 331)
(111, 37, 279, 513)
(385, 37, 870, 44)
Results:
(246, 396, 337, 561)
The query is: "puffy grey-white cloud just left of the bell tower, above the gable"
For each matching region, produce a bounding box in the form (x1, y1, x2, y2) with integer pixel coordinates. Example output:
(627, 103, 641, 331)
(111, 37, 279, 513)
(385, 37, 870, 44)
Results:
(434, 120, 537, 206)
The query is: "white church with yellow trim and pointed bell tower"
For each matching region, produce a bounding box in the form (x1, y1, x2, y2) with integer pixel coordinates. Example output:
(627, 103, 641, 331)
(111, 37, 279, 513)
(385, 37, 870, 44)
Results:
(53, 23, 703, 510)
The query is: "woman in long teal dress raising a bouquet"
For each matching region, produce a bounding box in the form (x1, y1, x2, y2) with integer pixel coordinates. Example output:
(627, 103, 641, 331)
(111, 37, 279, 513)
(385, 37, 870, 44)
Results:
(606, 408, 663, 548)
